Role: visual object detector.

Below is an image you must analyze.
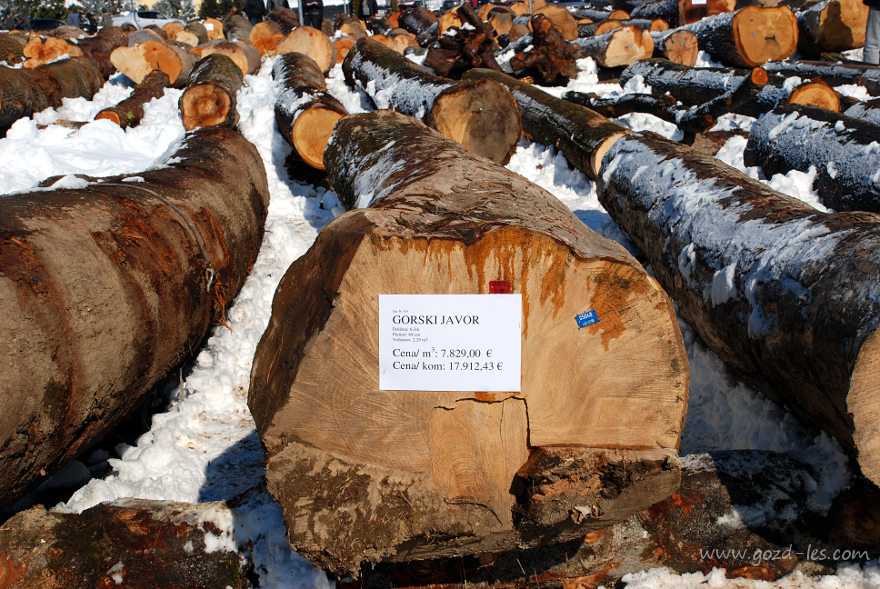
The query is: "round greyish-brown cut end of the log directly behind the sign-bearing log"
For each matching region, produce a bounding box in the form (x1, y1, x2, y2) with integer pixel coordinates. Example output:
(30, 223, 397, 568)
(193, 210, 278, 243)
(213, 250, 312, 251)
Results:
(425, 80, 522, 164)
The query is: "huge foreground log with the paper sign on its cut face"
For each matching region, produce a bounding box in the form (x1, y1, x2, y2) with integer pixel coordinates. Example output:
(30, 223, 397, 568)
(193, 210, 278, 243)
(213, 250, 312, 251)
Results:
(248, 111, 687, 576)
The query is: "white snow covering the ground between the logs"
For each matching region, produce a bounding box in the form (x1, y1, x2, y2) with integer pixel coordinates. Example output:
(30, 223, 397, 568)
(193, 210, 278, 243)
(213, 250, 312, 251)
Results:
(0, 47, 880, 588)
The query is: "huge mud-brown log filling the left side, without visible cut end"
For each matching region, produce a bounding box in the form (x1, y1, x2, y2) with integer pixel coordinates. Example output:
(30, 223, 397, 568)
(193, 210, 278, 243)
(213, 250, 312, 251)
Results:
(0, 129, 269, 505)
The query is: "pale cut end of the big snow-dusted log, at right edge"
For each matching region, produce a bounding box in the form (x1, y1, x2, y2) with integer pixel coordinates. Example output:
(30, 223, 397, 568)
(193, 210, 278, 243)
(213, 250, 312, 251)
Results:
(846, 331, 880, 485)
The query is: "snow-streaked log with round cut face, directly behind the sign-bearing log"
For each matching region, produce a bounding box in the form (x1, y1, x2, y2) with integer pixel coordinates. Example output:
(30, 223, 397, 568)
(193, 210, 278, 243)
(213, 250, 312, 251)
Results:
(342, 38, 522, 163)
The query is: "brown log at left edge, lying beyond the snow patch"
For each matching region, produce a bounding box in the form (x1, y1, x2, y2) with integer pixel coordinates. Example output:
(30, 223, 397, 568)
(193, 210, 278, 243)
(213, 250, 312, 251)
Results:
(0, 57, 104, 136)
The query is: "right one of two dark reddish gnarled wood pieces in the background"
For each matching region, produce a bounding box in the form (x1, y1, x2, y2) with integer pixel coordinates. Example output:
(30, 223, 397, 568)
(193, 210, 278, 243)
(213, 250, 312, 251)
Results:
(510, 14, 581, 86)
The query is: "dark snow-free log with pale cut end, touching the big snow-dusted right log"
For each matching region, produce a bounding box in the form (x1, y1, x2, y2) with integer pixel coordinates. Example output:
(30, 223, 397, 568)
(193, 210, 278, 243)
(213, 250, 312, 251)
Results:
(465, 69, 628, 180)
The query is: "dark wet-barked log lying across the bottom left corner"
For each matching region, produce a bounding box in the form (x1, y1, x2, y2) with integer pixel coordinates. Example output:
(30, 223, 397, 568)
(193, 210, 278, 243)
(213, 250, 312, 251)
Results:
(0, 499, 250, 589)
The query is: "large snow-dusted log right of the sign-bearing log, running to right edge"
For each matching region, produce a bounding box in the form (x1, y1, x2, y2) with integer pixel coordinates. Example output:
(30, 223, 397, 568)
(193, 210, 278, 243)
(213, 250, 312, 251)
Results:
(597, 133, 880, 483)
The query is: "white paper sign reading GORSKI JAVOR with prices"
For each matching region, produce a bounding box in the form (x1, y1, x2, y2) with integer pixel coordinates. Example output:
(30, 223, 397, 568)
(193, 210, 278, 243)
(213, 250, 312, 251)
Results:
(379, 294, 522, 392)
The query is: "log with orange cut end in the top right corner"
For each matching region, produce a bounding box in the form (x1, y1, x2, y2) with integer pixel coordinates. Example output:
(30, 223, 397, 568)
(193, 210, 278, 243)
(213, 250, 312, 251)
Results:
(795, 0, 868, 58)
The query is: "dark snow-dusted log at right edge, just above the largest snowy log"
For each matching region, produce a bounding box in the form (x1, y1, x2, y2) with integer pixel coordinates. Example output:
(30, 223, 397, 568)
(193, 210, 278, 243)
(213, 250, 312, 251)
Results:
(743, 105, 880, 213)
